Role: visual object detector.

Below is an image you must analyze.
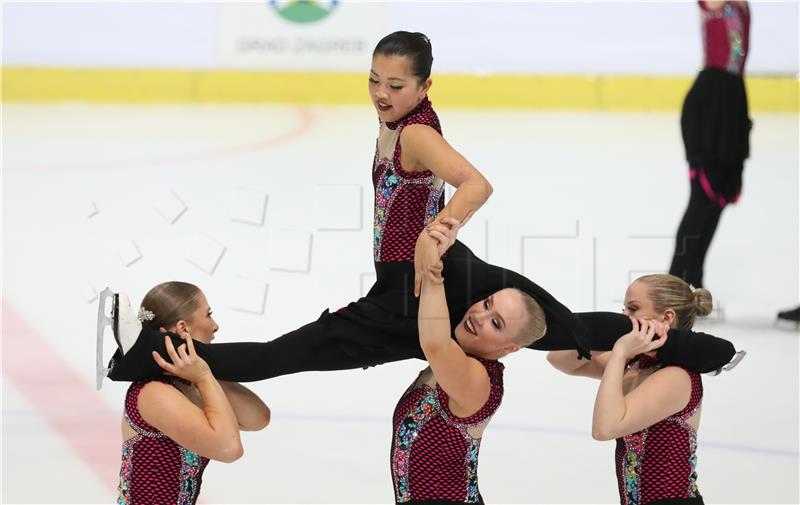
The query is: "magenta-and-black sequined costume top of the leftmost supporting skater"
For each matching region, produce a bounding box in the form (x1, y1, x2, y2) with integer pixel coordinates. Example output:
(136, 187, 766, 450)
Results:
(117, 378, 208, 505)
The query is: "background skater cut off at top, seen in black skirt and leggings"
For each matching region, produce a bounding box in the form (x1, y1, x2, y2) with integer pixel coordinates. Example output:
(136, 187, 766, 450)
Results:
(669, 0, 752, 288)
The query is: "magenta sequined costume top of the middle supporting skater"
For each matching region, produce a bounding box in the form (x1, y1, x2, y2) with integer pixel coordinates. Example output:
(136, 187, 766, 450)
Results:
(390, 358, 504, 503)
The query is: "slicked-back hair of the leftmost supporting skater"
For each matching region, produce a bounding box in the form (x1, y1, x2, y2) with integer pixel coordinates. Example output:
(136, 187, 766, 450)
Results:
(140, 281, 200, 329)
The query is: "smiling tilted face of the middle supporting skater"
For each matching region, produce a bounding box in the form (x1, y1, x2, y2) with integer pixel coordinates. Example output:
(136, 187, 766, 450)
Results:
(455, 289, 528, 359)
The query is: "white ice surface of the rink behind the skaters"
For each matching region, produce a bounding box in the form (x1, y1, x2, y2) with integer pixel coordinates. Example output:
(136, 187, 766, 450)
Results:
(0, 104, 800, 504)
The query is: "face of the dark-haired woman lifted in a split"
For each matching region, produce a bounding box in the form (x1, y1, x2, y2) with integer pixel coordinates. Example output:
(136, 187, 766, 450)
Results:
(369, 54, 431, 122)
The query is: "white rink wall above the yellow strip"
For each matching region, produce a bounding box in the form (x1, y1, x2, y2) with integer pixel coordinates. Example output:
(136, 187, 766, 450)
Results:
(2, 0, 800, 76)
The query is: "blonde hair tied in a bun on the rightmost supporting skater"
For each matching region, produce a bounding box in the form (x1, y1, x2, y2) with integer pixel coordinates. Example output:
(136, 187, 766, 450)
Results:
(636, 274, 713, 330)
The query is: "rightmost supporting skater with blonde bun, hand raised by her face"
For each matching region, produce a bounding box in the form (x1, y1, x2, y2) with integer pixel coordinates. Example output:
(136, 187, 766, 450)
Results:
(547, 274, 711, 505)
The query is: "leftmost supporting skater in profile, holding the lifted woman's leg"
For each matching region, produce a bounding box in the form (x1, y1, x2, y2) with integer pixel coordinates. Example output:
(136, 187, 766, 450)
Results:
(117, 282, 270, 505)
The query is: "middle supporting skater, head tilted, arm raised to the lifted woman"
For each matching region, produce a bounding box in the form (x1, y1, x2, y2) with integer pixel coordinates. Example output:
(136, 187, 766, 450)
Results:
(390, 216, 545, 503)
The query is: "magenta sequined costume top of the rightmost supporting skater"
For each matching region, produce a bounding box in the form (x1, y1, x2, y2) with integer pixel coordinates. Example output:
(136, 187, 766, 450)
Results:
(616, 355, 703, 505)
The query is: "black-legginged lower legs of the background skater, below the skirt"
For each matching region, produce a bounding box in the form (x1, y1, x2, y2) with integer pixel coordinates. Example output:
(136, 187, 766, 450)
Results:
(669, 177, 722, 288)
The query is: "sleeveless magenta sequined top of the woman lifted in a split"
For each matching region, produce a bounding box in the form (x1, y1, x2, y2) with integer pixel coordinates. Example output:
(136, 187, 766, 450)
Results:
(372, 97, 444, 261)
